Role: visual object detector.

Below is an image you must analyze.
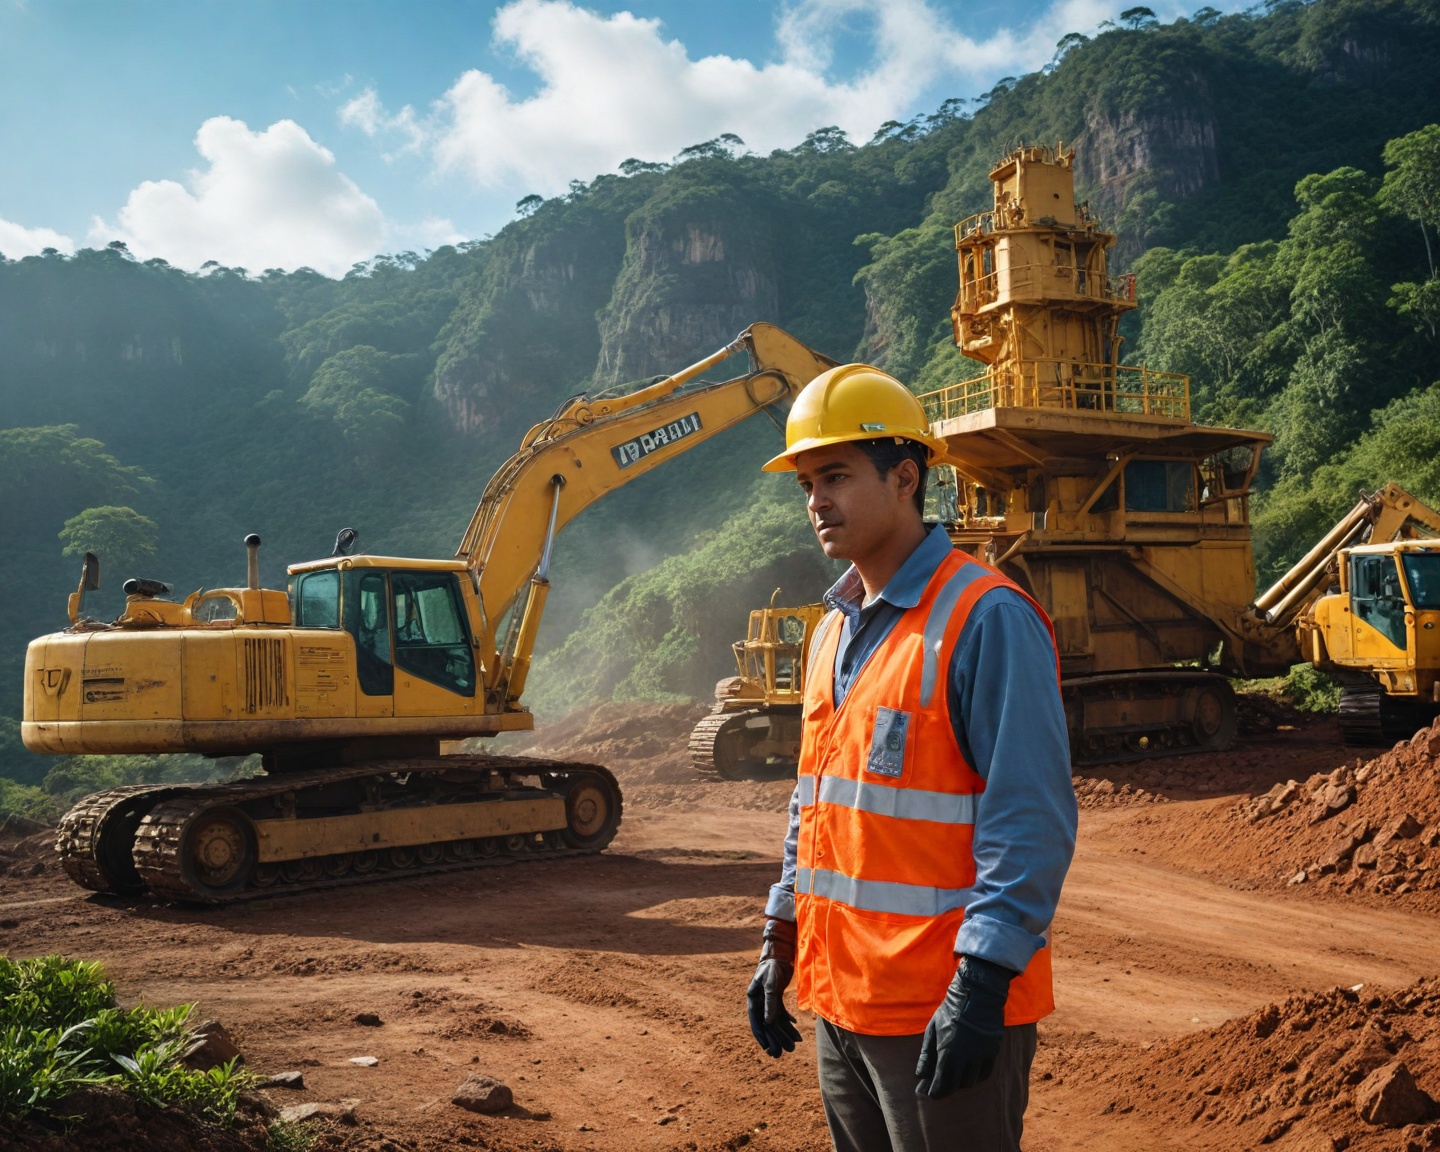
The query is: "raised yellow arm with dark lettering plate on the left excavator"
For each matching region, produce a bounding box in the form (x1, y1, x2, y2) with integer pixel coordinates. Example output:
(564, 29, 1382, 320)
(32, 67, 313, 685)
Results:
(455, 324, 835, 707)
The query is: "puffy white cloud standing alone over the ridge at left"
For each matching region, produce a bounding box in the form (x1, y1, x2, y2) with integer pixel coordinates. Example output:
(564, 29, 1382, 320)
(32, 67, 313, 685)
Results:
(89, 117, 455, 276)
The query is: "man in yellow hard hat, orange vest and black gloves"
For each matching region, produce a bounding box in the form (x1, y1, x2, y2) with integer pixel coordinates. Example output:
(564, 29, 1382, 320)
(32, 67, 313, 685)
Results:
(747, 364, 1077, 1152)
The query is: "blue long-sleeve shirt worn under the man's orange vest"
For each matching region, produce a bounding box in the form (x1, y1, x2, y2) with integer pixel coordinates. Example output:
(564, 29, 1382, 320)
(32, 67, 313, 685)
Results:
(765, 527, 1077, 972)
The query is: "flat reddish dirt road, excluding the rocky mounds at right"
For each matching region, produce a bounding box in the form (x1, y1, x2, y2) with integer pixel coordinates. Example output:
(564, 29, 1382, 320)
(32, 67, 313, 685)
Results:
(0, 710, 1440, 1152)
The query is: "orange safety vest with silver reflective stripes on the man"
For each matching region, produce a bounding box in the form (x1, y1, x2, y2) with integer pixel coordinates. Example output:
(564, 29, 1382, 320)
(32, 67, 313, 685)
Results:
(795, 552, 1058, 1035)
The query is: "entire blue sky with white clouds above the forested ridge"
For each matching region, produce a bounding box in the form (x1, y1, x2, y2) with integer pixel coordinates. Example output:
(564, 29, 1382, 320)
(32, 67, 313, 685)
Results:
(0, 0, 1244, 275)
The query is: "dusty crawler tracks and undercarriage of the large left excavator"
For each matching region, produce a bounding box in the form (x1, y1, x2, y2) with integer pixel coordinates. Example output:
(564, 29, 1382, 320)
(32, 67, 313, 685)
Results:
(58, 756, 622, 904)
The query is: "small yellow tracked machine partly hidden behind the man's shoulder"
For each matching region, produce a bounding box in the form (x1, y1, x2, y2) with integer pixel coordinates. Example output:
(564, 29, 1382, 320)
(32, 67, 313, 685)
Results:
(690, 589, 825, 780)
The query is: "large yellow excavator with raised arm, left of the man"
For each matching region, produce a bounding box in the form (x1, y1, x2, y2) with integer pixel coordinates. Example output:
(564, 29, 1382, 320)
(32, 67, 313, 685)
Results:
(22, 324, 834, 903)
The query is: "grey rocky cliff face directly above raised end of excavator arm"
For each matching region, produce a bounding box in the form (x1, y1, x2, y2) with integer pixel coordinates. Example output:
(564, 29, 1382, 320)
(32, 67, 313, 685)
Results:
(595, 204, 779, 387)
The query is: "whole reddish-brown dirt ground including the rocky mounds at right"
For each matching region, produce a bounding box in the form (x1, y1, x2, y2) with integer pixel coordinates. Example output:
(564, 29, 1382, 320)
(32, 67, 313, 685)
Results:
(0, 698, 1440, 1152)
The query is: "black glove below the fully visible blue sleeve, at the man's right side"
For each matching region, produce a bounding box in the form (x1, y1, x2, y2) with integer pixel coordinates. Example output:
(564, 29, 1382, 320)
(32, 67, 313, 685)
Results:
(914, 956, 1015, 1100)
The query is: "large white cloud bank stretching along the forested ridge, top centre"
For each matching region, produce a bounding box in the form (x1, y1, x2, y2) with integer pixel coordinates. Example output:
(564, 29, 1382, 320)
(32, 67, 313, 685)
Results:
(354, 0, 1240, 194)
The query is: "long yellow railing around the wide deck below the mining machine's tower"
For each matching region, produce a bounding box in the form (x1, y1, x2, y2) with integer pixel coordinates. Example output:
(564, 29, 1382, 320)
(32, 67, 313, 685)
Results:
(920, 360, 1189, 423)
